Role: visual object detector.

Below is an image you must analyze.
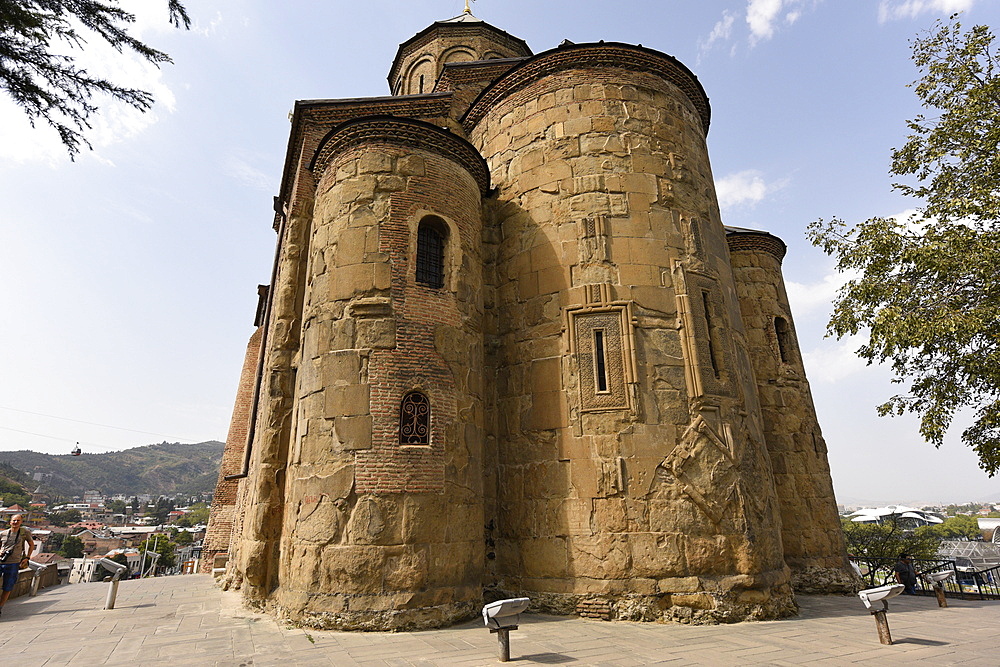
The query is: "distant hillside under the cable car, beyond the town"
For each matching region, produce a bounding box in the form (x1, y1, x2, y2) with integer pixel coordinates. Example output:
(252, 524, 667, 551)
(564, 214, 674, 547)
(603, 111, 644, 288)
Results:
(0, 440, 223, 497)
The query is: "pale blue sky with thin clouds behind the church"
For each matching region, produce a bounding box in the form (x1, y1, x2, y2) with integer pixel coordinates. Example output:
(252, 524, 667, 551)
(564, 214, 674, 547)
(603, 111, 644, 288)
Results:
(0, 0, 1000, 503)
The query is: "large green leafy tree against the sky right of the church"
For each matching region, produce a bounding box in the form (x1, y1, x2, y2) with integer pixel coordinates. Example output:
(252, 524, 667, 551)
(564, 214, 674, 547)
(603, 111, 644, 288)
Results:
(809, 15, 1000, 476)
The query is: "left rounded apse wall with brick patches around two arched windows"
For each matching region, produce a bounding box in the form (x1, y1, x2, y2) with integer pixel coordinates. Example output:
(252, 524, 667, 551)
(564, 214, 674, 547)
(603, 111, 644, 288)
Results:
(274, 142, 483, 630)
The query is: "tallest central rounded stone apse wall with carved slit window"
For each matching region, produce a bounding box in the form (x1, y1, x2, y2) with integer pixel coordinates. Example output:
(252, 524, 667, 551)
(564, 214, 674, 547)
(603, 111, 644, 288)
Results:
(470, 54, 795, 622)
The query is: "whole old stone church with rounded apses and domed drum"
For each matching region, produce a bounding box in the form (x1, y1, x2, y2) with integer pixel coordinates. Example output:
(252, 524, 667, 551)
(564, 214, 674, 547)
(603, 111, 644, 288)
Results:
(205, 11, 853, 630)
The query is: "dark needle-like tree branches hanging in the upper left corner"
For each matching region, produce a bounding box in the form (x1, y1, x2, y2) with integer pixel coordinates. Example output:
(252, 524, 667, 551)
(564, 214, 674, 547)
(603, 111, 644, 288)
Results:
(0, 0, 191, 157)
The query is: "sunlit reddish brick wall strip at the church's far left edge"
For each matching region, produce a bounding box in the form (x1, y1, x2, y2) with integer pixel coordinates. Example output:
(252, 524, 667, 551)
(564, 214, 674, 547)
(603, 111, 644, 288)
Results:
(201, 327, 264, 574)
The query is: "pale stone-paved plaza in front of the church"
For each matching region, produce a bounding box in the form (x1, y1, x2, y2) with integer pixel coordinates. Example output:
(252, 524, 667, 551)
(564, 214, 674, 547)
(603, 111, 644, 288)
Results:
(0, 575, 1000, 667)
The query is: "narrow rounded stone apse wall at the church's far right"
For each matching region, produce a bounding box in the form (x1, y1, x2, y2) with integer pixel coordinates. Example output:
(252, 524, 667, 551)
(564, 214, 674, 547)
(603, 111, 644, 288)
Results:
(729, 233, 858, 593)
